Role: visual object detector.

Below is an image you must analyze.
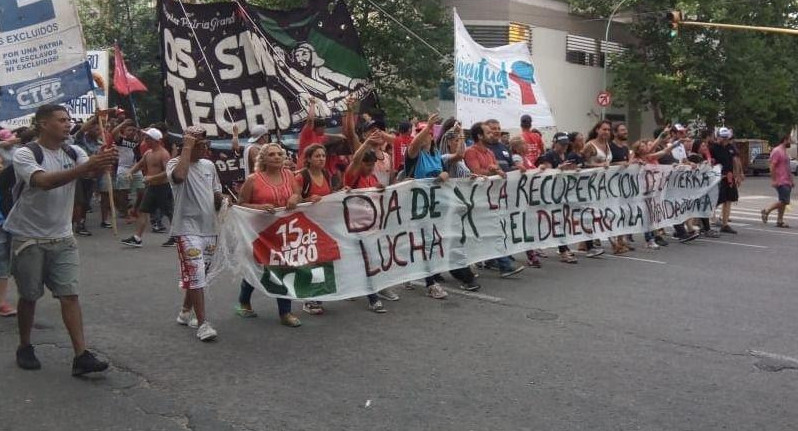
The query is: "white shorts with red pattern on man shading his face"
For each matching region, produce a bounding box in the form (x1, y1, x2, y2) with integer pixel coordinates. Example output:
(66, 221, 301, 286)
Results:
(177, 235, 216, 290)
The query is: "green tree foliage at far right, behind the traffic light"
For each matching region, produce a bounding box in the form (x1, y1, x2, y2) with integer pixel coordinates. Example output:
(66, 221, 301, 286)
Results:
(571, 0, 798, 139)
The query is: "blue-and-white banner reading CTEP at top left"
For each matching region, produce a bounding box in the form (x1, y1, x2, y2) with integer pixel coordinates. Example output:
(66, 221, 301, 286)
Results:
(0, 0, 93, 120)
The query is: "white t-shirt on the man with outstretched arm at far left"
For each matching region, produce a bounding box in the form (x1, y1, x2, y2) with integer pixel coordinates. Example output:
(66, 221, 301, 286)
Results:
(3, 145, 89, 239)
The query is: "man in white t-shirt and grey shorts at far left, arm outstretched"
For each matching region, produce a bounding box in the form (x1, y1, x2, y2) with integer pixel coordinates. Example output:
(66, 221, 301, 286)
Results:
(4, 105, 117, 376)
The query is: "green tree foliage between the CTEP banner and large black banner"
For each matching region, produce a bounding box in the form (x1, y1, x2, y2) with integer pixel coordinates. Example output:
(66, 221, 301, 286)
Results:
(78, 0, 163, 125)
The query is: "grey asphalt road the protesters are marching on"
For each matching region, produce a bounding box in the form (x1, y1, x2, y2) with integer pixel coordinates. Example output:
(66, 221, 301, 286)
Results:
(0, 178, 798, 430)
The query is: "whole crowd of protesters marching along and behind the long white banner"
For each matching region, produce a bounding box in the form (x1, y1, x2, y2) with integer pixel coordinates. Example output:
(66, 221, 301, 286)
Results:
(0, 100, 793, 375)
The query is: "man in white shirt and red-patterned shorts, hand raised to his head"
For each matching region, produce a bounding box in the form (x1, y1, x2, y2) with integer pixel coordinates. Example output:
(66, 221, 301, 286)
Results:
(166, 126, 222, 341)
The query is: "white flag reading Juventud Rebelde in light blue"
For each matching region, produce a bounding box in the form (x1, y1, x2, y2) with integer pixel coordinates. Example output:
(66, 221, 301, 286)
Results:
(454, 13, 555, 128)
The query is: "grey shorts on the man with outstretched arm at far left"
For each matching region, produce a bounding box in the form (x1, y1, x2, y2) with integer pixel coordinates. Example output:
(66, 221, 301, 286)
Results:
(11, 237, 80, 301)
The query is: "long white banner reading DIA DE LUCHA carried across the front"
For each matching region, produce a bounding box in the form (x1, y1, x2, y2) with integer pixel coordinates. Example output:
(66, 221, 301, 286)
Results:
(219, 165, 720, 301)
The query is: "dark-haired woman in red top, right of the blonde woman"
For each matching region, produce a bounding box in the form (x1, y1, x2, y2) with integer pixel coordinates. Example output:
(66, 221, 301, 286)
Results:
(294, 144, 333, 315)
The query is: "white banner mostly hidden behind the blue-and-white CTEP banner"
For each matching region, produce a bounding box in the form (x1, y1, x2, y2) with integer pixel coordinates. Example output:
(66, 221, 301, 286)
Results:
(0, 50, 110, 129)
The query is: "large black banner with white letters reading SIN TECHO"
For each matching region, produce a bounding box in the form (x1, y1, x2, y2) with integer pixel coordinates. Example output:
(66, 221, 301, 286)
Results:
(158, 0, 376, 137)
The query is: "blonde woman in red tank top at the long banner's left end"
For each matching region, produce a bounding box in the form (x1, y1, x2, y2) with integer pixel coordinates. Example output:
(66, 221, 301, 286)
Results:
(236, 144, 302, 328)
